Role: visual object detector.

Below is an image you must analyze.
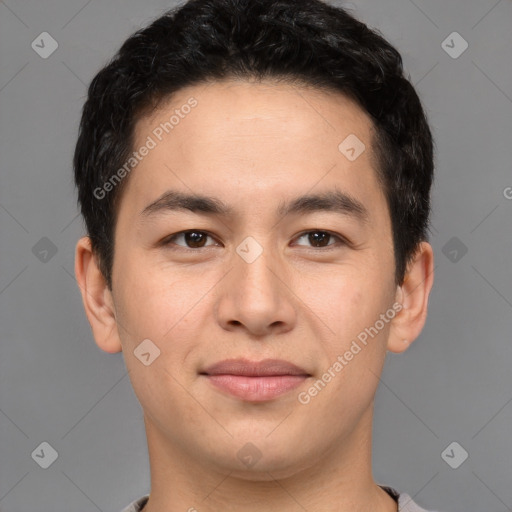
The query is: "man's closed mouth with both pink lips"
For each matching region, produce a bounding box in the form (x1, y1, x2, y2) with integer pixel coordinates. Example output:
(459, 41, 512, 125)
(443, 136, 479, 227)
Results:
(200, 359, 311, 402)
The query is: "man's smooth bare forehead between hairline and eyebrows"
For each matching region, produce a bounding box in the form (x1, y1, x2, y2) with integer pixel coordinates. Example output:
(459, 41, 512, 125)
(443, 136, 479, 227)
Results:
(122, 80, 382, 222)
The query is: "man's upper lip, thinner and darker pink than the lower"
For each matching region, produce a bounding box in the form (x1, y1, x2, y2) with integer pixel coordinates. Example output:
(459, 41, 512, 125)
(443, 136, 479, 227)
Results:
(201, 359, 309, 377)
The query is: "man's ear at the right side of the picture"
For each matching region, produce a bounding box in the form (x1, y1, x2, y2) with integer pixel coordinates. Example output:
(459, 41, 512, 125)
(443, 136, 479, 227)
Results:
(387, 242, 434, 353)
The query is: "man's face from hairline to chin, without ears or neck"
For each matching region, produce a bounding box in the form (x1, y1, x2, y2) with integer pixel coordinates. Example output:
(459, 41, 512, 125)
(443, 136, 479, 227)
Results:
(108, 81, 397, 478)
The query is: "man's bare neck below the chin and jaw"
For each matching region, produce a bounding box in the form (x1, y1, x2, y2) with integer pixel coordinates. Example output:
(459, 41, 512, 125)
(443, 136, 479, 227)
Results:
(143, 404, 398, 512)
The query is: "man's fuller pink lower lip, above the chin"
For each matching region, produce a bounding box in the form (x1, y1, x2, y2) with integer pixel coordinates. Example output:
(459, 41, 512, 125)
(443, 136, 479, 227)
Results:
(203, 375, 308, 402)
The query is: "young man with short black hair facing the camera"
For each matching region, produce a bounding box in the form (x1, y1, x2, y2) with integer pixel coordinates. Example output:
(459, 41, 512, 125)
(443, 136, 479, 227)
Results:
(74, 0, 434, 512)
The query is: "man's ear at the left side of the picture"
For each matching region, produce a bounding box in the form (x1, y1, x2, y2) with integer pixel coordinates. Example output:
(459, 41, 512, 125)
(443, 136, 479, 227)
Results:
(75, 236, 122, 354)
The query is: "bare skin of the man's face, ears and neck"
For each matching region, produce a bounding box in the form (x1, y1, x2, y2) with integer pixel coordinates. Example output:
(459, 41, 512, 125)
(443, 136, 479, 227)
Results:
(75, 80, 433, 512)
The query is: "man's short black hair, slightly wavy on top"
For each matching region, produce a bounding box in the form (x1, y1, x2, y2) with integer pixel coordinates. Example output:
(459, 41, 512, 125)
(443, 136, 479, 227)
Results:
(73, 0, 434, 289)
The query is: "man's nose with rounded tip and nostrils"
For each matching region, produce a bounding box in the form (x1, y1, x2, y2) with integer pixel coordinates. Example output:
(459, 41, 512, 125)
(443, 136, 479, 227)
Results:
(216, 241, 297, 337)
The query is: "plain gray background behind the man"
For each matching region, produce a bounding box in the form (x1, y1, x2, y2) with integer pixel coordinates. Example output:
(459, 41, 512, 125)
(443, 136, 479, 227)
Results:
(0, 0, 512, 512)
